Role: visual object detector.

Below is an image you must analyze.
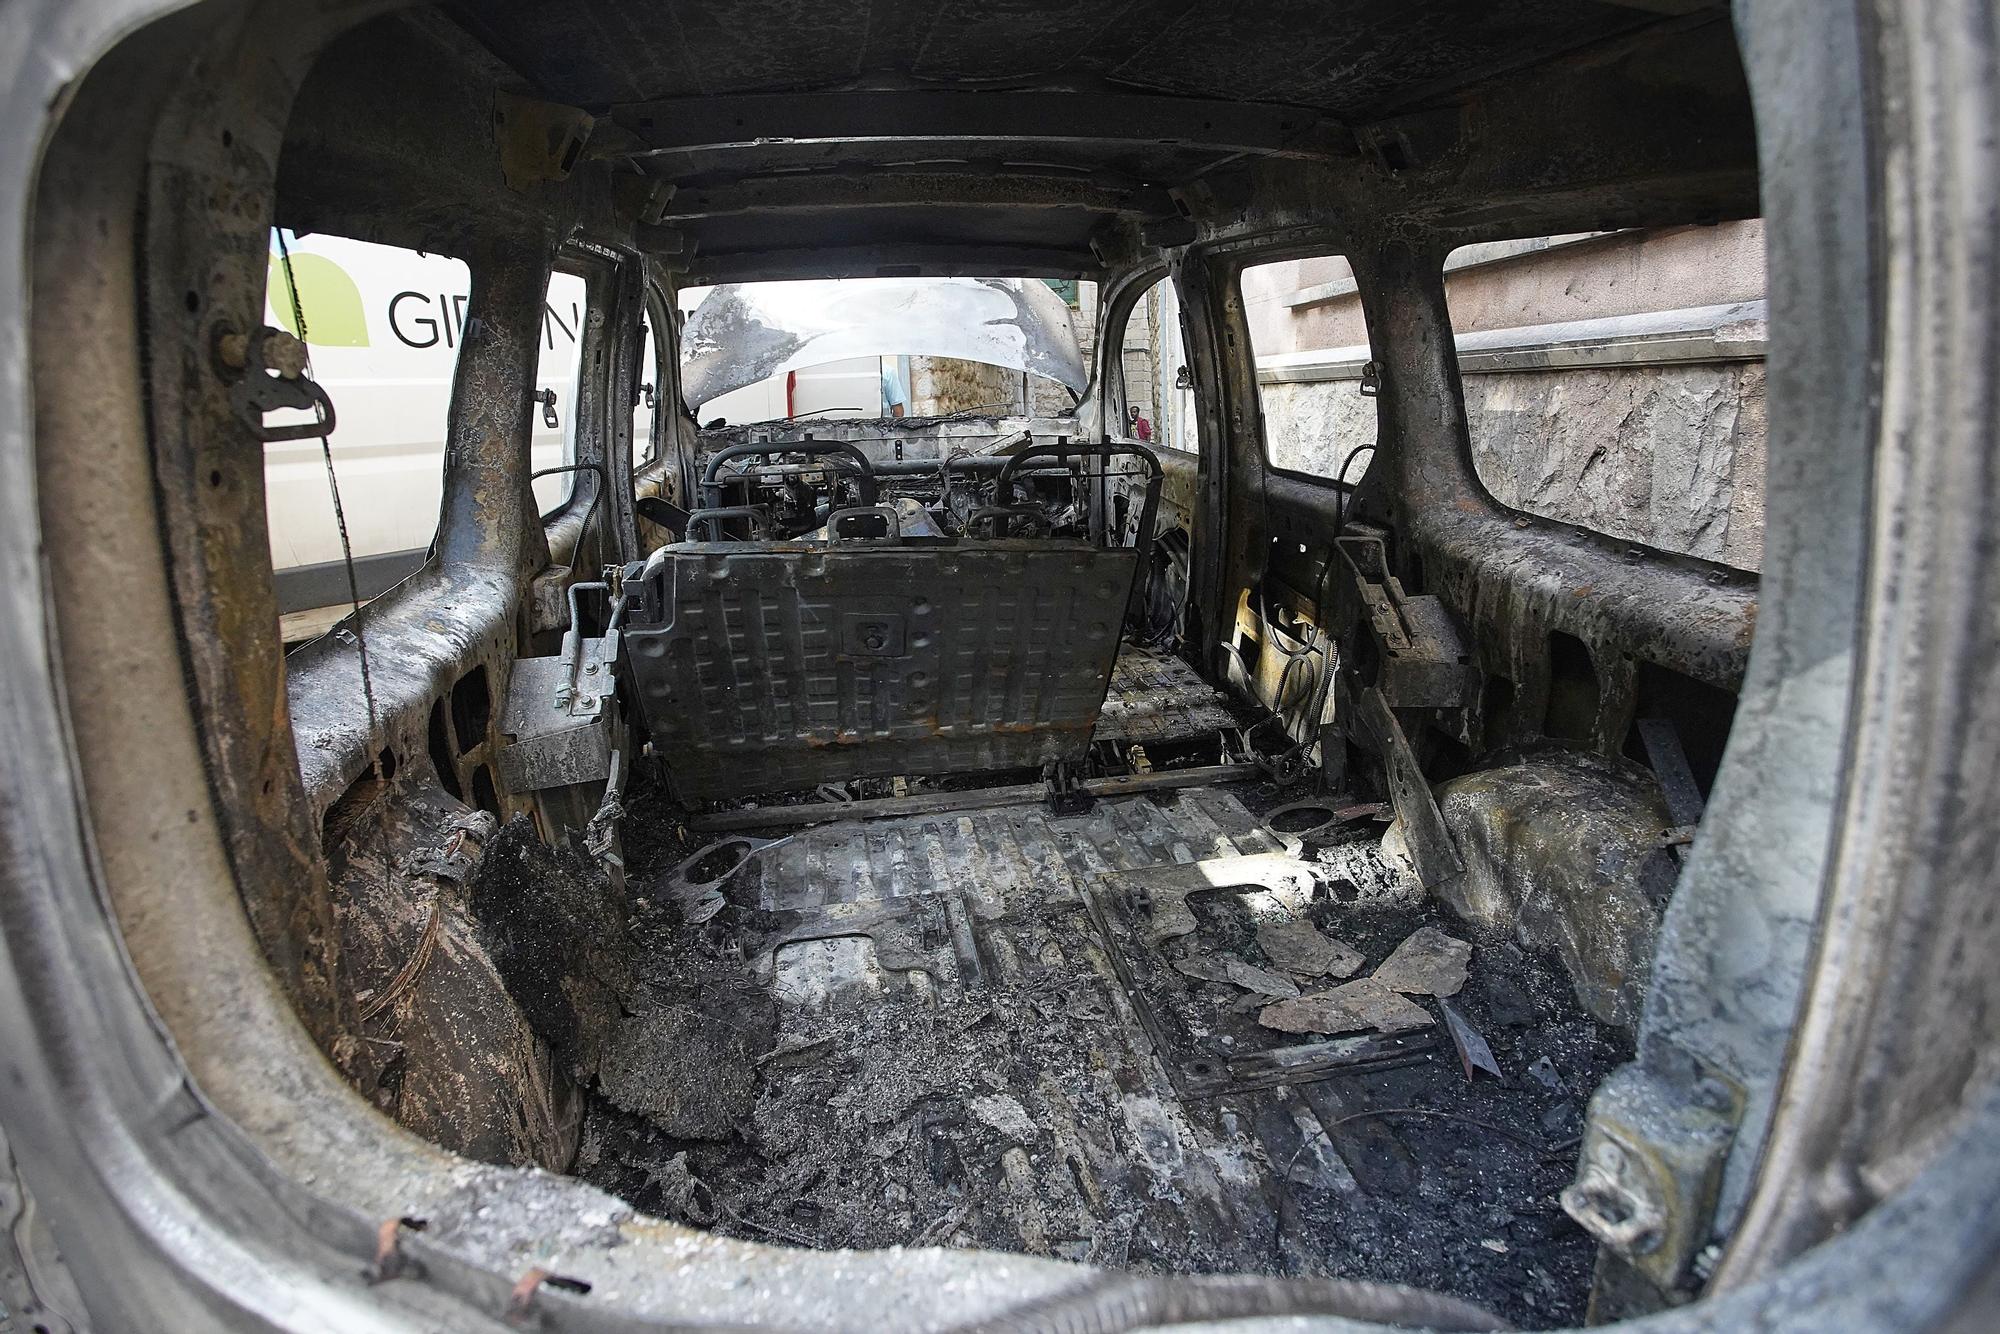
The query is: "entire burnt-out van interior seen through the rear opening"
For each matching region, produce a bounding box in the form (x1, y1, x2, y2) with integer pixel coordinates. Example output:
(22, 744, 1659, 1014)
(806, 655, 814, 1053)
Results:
(36, 0, 1968, 1330)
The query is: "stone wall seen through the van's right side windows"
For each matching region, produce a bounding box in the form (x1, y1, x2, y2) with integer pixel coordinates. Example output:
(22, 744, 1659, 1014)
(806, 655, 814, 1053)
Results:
(1242, 220, 1764, 570)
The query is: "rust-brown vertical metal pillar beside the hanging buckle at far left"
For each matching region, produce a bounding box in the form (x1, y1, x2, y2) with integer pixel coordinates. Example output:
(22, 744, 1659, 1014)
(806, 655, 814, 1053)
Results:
(133, 0, 372, 1068)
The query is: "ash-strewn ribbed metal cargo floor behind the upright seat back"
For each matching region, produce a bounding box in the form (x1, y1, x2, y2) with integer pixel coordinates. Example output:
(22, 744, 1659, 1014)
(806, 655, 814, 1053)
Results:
(578, 790, 1620, 1326)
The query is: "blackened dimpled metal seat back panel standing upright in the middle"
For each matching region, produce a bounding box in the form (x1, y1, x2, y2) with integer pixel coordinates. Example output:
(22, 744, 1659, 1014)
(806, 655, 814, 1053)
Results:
(624, 540, 1136, 802)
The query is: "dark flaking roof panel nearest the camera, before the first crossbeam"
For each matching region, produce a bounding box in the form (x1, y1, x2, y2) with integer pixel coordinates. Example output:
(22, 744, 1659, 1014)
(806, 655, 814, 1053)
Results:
(448, 0, 1726, 122)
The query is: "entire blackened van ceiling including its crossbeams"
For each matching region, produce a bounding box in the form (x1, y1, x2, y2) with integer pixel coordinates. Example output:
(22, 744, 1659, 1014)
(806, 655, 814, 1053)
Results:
(280, 0, 1756, 282)
